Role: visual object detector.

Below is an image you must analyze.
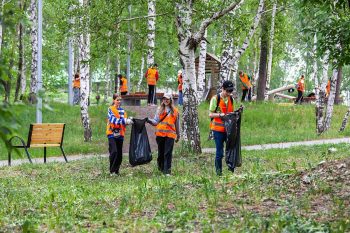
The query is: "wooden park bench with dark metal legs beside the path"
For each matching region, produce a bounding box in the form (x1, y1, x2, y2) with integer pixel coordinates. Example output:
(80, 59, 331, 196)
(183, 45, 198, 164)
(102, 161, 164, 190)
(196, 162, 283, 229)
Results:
(8, 123, 68, 166)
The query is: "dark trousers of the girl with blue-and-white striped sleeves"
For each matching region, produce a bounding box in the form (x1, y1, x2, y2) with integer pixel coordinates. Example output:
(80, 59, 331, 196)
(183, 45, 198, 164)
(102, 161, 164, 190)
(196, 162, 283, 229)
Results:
(108, 138, 124, 174)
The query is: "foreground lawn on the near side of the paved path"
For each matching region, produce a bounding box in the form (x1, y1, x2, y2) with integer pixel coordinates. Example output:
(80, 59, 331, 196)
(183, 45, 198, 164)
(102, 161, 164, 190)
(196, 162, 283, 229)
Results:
(0, 144, 350, 232)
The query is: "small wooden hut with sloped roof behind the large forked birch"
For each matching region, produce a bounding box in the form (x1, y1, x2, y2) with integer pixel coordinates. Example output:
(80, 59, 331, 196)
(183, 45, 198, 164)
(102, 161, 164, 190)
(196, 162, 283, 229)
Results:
(195, 53, 221, 100)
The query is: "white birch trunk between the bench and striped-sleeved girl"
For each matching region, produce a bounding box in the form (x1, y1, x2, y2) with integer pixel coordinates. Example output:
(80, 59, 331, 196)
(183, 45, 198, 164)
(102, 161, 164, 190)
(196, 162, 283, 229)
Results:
(79, 0, 92, 142)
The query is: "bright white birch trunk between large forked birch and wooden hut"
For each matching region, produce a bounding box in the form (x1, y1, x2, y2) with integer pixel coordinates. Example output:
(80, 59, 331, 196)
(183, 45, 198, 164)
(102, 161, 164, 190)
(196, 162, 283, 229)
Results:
(197, 30, 207, 101)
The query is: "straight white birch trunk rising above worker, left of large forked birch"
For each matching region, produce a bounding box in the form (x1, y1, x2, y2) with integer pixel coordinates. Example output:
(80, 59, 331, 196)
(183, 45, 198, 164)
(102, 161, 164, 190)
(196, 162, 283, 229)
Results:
(147, 0, 156, 67)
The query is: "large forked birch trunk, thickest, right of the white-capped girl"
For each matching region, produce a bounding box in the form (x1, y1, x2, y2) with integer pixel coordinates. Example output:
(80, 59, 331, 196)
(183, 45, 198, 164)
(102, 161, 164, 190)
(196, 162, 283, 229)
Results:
(175, 0, 243, 153)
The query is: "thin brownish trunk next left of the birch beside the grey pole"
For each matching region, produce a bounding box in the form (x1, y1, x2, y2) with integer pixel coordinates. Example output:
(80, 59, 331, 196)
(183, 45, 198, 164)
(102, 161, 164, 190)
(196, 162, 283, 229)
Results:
(14, 0, 24, 102)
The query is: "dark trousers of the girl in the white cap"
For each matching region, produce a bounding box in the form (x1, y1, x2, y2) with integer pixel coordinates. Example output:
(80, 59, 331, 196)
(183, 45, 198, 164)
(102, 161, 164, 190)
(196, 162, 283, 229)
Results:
(156, 136, 175, 174)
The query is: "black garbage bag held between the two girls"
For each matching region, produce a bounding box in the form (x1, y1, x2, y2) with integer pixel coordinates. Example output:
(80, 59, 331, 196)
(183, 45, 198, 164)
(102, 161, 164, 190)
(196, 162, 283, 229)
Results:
(129, 118, 152, 166)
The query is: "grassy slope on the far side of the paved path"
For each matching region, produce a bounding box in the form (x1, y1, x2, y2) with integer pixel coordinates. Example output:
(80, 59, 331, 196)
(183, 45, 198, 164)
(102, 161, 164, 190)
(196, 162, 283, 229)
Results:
(0, 103, 350, 160)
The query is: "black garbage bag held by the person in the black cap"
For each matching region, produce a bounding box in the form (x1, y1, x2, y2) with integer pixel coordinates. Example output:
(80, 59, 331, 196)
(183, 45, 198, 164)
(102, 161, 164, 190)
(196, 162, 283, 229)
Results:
(222, 107, 243, 172)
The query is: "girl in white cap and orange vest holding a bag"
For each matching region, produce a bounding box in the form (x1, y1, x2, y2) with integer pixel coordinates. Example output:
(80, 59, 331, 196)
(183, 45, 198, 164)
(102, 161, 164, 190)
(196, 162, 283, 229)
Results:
(148, 93, 180, 175)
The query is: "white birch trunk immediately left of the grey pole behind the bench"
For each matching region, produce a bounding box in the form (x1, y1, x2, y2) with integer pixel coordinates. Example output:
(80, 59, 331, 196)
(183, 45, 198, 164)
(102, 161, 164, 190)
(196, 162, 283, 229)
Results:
(29, 0, 38, 104)
